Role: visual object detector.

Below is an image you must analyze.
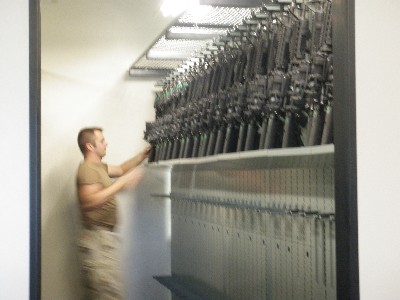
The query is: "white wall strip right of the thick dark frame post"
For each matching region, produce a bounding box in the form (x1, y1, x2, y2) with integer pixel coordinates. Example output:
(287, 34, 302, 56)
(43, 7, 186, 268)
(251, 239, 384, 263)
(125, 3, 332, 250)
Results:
(355, 0, 400, 300)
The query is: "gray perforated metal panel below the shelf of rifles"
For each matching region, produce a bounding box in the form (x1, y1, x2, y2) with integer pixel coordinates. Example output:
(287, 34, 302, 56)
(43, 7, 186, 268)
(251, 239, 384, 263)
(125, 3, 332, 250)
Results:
(171, 149, 336, 300)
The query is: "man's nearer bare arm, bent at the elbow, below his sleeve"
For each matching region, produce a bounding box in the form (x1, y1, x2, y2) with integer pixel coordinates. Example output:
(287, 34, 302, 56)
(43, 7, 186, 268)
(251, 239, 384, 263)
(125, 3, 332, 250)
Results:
(78, 167, 144, 211)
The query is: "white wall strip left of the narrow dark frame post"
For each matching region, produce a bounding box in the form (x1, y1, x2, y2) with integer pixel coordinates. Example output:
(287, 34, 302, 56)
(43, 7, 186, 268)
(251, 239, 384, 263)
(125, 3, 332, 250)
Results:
(0, 0, 29, 299)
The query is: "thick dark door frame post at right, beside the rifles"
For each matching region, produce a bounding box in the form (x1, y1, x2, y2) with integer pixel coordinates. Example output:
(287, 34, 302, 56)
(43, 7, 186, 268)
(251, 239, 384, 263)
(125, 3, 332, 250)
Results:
(332, 0, 360, 300)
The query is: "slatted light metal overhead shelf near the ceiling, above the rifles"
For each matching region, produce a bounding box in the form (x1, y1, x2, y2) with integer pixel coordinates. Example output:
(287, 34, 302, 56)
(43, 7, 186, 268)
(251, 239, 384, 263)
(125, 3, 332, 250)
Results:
(129, 5, 262, 78)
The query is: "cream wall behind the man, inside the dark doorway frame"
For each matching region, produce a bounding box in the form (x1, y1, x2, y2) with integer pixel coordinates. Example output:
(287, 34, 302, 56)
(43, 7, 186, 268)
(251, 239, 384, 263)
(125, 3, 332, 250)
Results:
(41, 0, 170, 300)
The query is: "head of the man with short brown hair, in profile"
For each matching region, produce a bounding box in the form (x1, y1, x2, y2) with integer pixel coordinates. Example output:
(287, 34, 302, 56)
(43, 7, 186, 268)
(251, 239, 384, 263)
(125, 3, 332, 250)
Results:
(78, 127, 107, 157)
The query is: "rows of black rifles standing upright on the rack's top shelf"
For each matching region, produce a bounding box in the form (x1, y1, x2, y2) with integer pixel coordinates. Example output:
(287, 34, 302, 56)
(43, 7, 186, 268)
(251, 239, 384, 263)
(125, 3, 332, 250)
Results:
(145, 0, 333, 162)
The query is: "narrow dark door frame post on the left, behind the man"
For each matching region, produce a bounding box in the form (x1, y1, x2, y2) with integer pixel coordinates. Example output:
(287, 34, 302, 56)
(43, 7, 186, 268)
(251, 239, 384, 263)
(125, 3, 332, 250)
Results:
(29, 0, 41, 300)
